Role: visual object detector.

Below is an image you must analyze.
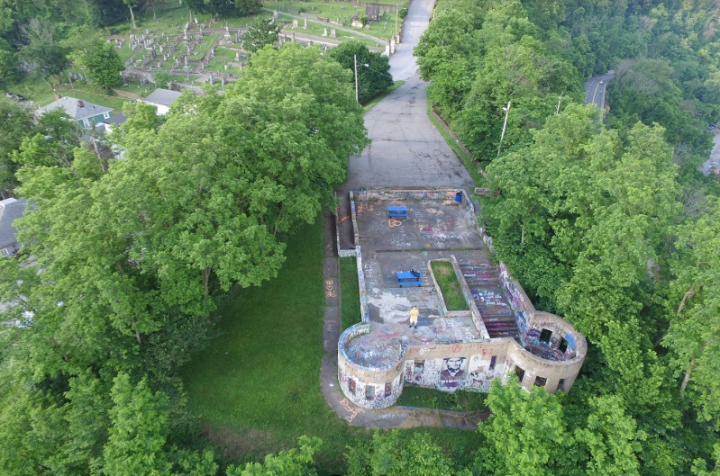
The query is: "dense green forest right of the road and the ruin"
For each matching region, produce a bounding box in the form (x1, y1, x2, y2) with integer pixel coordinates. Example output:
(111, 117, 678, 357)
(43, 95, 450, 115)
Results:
(416, 0, 720, 475)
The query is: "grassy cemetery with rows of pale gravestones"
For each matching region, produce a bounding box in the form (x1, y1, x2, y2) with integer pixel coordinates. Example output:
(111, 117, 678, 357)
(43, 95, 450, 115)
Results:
(107, 3, 388, 91)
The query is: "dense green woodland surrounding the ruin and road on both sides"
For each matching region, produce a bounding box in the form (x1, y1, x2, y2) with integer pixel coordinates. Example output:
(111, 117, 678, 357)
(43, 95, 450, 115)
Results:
(0, 0, 720, 476)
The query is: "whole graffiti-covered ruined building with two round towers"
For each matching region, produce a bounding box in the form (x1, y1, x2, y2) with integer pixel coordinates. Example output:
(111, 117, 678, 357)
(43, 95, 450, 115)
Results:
(338, 189, 587, 408)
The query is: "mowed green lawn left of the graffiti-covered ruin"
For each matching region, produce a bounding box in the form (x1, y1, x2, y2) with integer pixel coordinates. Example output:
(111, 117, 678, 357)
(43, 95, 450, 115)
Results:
(182, 218, 367, 474)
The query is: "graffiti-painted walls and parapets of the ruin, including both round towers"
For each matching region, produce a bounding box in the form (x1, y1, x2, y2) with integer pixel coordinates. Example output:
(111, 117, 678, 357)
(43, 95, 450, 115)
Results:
(338, 189, 587, 409)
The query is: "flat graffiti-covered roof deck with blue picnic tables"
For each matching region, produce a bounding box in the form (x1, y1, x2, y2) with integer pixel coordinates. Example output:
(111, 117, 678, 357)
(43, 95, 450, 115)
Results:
(346, 198, 491, 367)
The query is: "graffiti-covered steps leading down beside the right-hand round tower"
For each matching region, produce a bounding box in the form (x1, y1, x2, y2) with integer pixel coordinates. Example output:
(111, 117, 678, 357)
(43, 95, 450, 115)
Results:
(460, 265, 520, 339)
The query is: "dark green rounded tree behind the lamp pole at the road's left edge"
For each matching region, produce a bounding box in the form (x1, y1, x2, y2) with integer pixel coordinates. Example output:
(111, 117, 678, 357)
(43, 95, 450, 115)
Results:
(328, 41, 393, 102)
